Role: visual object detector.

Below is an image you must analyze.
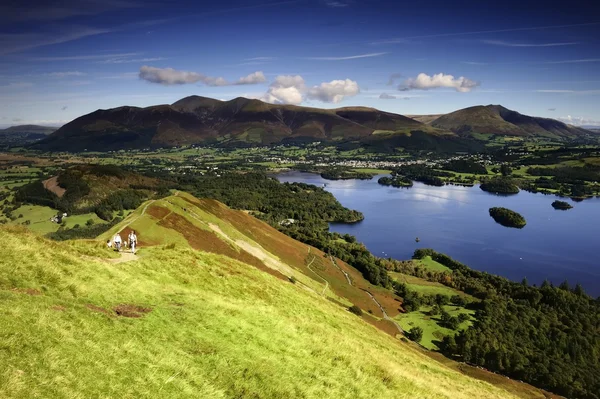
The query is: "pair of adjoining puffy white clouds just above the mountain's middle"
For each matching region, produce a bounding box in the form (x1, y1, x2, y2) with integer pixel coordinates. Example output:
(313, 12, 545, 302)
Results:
(260, 75, 360, 104)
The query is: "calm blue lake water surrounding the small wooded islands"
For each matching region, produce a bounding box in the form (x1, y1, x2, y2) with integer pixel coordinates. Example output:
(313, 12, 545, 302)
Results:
(277, 172, 600, 296)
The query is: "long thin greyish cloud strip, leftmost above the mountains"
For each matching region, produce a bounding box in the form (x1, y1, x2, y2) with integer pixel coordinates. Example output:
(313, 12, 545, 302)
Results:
(139, 65, 266, 86)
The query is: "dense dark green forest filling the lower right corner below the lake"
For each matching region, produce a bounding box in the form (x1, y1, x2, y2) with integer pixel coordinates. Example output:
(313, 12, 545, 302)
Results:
(410, 249, 600, 399)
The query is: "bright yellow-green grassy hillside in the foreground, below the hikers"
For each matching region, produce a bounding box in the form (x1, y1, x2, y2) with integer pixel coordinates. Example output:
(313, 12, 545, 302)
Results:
(0, 228, 510, 398)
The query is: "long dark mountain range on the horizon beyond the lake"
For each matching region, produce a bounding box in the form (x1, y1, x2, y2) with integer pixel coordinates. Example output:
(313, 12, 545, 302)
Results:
(34, 96, 592, 151)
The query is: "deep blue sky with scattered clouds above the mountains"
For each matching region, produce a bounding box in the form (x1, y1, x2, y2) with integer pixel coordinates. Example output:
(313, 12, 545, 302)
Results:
(0, 0, 600, 126)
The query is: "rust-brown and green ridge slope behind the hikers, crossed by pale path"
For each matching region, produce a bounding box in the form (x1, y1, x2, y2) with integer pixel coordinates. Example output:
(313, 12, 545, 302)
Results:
(100, 192, 400, 320)
